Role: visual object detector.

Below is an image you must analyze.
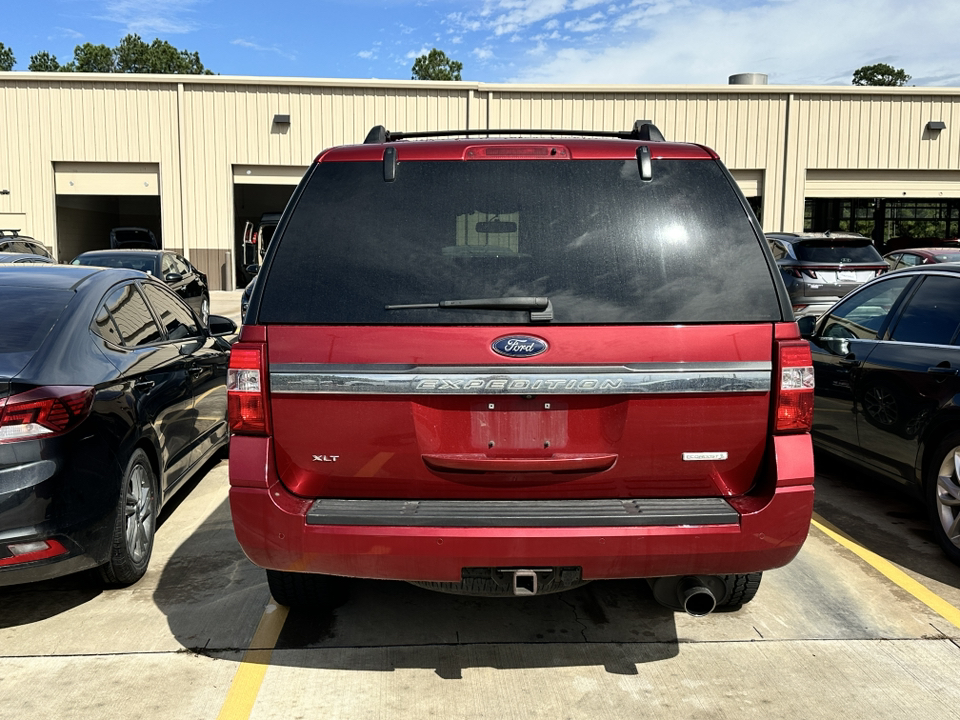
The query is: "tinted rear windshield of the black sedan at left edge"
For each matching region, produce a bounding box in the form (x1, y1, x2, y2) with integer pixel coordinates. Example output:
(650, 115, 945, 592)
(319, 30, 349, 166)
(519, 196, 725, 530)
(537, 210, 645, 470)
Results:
(0, 287, 74, 353)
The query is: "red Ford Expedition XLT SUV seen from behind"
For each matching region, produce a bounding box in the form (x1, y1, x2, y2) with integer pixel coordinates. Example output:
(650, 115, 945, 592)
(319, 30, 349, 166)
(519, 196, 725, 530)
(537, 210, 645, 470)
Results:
(228, 121, 813, 615)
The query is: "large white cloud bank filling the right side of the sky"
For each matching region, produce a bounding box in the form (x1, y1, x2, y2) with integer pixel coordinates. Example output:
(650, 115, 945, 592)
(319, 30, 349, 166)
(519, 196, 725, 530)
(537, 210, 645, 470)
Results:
(510, 0, 960, 85)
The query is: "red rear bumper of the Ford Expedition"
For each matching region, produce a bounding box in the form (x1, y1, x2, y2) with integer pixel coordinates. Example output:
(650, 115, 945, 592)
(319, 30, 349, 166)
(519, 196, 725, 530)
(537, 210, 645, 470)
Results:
(230, 435, 813, 582)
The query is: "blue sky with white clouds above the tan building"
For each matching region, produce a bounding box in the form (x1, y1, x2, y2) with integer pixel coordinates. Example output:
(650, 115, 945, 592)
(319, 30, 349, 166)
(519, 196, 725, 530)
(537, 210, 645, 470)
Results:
(0, 0, 960, 86)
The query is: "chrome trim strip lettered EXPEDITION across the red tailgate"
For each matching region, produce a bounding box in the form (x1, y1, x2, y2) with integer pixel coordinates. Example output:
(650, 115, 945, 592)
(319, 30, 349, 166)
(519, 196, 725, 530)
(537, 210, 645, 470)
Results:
(270, 363, 773, 395)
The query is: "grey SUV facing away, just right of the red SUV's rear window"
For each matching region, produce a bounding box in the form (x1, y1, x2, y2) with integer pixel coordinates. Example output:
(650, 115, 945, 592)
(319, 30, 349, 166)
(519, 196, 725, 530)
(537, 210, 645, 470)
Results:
(767, 232, 888, 317)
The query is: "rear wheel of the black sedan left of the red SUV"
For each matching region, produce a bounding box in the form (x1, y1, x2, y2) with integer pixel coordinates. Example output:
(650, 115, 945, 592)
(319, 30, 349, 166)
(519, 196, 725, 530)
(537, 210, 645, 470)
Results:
(100, 449, 157, 587)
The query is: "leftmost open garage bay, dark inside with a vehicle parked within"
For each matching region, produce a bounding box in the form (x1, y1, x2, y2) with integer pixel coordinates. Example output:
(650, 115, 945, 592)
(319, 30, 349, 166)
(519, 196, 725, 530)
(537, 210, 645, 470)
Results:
(57, 195, 164, 262)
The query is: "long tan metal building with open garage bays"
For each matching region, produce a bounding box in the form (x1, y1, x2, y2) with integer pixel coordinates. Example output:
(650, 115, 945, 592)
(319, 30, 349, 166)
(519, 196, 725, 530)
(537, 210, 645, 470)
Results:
(0, 72, 960, 288)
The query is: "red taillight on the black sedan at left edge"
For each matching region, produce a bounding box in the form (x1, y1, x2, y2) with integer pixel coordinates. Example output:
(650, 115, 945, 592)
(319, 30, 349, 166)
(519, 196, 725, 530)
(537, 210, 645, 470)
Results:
(0, 385, 93, 443)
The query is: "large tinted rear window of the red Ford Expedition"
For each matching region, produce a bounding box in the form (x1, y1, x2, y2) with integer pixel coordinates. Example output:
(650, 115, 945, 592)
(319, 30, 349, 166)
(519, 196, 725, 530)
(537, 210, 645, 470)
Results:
(258, 159, 781, 325)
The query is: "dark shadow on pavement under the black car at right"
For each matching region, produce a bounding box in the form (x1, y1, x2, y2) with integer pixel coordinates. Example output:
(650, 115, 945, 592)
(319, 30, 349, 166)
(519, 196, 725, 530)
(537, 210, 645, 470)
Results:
(814, 452, 960, 588)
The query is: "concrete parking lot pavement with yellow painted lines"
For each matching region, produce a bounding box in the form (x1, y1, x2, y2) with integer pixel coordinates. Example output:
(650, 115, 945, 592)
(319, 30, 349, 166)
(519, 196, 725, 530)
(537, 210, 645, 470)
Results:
(0, 293, 960, 720)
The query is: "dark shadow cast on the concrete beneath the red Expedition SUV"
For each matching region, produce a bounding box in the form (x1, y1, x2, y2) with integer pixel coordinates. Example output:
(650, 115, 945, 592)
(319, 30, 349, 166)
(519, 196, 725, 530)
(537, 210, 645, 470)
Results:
(154, 502, 679, 678)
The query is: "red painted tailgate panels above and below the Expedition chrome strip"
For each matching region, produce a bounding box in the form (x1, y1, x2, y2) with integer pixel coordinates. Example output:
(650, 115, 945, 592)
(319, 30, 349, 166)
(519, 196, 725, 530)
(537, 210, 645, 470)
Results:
(267, 324, 773, 500)
